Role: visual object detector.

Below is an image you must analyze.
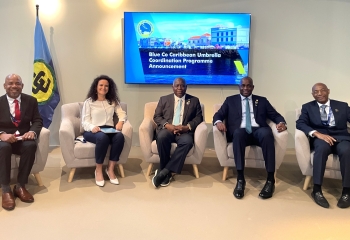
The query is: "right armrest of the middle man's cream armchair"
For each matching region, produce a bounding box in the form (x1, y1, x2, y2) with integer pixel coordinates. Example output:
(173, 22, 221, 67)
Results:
(193, 122, 208, 164)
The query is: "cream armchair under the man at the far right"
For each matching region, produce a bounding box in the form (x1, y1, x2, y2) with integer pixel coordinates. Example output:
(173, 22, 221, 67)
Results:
(295, 108, 350, 190)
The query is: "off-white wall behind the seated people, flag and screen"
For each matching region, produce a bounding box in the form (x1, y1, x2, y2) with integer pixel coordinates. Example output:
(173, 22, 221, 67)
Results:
(0, 0, 350, 148)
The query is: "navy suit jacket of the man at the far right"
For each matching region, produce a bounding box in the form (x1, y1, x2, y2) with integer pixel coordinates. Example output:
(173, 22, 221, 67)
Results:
(296, 100, 350, 141)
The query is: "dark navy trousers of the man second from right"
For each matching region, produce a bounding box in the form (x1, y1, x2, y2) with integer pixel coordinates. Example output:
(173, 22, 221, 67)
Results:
(232, 127, 276, 172)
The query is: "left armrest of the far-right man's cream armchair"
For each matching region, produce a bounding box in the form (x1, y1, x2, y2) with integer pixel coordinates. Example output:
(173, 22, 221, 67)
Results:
(295, 129, 312, 176)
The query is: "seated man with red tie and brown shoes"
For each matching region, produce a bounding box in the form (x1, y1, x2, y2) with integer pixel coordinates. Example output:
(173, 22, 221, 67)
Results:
(0, 74, 42, 210)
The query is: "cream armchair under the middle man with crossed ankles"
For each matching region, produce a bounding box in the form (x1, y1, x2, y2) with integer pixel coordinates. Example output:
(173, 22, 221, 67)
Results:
(139, 102, 208, 178)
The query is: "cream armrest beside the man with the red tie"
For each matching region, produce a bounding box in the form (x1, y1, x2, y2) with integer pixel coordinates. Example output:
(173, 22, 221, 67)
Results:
(33, 127, 50, 173)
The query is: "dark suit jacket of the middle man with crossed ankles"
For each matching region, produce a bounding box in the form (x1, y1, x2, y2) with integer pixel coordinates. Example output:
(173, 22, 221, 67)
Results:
(153, 94, 203, 133)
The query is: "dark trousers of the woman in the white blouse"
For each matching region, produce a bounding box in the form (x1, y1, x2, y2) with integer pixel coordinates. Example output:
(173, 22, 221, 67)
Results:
(83, 132, 124, 164)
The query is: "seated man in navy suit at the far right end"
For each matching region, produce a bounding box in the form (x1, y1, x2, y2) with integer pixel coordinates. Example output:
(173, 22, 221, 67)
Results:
(297, 83, 350, 208)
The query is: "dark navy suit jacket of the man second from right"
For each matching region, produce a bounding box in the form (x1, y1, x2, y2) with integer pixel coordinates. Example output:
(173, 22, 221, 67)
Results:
(213, 94, 286, 141)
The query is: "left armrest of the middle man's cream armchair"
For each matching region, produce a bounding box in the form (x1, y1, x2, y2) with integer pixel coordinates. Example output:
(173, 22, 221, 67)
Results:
(139, 118, 154, 160)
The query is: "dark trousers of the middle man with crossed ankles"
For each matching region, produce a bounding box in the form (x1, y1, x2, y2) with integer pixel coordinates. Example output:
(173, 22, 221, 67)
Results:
(156, 129, 193, 173)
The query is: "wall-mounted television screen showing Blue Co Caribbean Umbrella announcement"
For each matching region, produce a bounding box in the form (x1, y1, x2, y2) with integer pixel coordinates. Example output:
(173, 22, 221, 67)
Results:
(124, 12, 250, 85)
